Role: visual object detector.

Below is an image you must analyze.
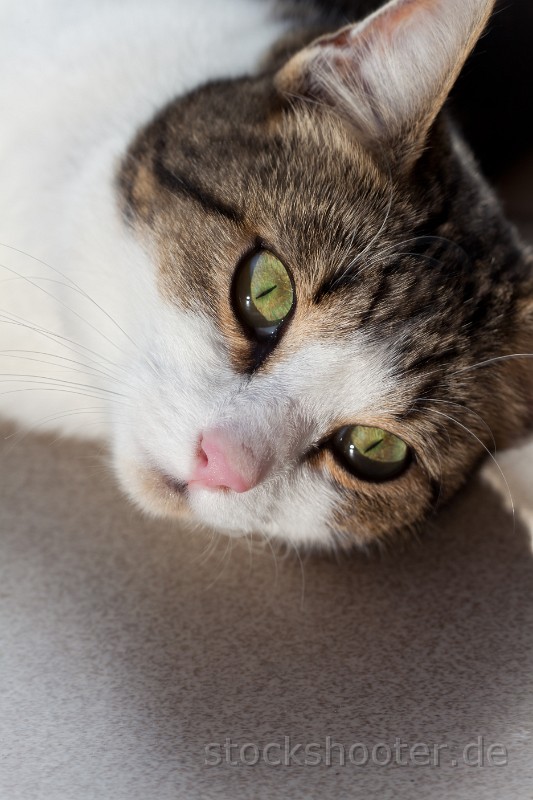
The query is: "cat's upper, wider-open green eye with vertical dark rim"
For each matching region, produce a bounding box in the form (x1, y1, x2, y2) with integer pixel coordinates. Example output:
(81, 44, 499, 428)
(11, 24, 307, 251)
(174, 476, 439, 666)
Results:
(233, 250, 294, 339)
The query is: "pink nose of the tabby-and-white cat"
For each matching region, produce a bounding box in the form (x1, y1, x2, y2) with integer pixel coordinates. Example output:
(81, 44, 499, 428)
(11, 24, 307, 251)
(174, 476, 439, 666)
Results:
(189, 430, 259, 492)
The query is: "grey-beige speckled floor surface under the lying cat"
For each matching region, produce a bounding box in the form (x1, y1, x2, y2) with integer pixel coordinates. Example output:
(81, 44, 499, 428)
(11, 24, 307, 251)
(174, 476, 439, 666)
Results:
(0, 164, 533, 800)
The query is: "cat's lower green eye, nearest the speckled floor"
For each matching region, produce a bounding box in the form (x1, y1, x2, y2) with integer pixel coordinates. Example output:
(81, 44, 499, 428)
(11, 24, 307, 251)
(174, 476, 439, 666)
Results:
(331, 425, 411, 481)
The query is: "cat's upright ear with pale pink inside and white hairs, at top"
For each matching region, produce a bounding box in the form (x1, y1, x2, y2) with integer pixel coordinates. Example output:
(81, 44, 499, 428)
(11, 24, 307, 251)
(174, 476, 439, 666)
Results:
(277, 0, 494, 166)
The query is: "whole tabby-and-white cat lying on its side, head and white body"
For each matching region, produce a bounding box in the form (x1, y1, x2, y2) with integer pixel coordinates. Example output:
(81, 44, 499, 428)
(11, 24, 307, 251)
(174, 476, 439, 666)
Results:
(0, 0, 533, 549)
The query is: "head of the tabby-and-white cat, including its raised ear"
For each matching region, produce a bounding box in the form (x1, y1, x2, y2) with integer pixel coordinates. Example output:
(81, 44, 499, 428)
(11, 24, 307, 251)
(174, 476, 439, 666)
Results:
(115, 0, 531, 546)
